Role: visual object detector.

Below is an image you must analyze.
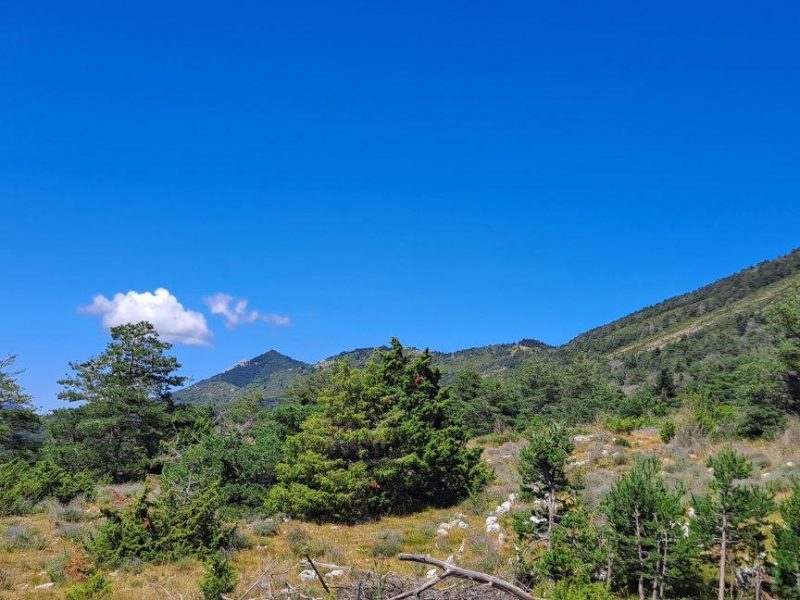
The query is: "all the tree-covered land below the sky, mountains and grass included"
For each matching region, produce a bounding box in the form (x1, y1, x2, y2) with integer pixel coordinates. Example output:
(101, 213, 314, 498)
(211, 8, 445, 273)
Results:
(0, 252, 800, 600)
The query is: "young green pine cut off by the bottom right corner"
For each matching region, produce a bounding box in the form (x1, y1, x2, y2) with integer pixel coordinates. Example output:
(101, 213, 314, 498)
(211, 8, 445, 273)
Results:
(772, 480, 800, 600)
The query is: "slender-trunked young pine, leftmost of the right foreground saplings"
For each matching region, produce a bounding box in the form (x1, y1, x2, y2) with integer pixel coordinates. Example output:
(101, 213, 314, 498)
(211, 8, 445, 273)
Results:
(519, 424, 575, 550)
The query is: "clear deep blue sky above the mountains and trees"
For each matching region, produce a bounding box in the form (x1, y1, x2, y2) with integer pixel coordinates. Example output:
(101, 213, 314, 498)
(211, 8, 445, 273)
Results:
(0, 1, 800, 408)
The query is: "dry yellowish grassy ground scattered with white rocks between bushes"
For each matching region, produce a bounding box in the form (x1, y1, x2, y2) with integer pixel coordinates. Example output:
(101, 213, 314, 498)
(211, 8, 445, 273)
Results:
(0, 422, 800, 600)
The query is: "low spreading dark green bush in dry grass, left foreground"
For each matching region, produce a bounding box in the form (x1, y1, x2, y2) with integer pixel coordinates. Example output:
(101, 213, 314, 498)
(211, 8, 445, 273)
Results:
(90, 485, 232, 567)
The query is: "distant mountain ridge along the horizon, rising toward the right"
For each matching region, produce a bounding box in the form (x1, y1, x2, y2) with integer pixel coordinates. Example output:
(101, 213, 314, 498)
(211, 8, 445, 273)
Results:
(175, 249, 800, 403)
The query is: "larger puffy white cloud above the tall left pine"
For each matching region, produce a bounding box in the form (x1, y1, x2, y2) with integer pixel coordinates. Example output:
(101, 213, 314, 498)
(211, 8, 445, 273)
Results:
(80, 288, 213, 346)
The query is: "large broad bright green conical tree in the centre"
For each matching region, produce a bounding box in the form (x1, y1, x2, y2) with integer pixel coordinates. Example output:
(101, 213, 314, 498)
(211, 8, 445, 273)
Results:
(266, 340, 488, 522)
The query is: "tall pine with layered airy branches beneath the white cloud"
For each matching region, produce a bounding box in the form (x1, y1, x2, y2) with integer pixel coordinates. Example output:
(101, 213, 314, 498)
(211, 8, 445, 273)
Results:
(49, 322, 185, 482)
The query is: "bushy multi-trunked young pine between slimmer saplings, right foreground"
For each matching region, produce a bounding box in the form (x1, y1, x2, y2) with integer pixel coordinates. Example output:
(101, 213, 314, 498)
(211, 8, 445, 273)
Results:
(604, 457, 683, 600)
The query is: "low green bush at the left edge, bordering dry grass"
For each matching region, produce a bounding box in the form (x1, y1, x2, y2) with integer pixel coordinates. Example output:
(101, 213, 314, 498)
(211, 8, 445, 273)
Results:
(0, 460, 97, 516)
